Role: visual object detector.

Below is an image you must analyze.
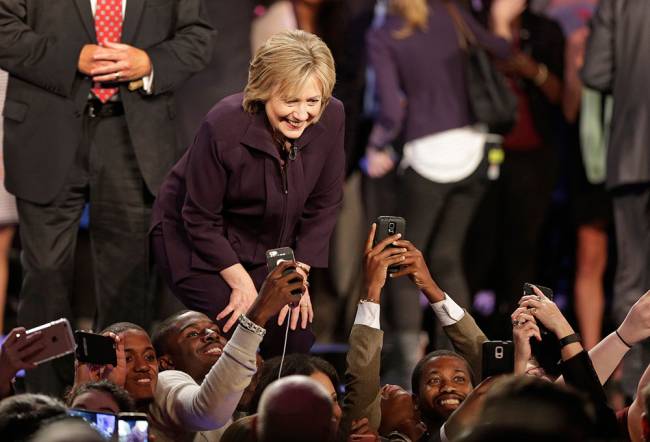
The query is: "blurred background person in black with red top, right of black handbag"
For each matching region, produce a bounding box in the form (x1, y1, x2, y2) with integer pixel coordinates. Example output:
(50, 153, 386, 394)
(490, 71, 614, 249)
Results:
(461, 0, 564, 339)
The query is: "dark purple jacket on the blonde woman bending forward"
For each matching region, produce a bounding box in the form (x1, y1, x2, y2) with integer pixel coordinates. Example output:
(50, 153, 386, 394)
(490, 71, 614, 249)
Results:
(153, 94, 345, 281)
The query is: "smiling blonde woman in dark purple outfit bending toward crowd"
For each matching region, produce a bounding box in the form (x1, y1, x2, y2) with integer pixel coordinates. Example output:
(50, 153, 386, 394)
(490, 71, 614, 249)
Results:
(151, 31, 345, 356)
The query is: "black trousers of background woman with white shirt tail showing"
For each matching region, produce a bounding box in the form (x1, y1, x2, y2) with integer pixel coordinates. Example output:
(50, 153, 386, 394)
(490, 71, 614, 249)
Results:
(382, 164, 487, 388)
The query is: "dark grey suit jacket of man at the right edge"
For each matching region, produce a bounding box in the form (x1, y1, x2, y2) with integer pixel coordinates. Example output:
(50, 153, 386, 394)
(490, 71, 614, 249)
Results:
(582, 0, 650, 188)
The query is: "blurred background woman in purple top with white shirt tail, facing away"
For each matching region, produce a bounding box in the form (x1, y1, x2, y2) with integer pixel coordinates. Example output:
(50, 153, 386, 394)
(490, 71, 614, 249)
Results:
(366, 0, 525, 387)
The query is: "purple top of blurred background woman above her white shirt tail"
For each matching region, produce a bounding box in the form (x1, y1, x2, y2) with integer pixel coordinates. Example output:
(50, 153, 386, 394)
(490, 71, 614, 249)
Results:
(366, 0, 511, 148)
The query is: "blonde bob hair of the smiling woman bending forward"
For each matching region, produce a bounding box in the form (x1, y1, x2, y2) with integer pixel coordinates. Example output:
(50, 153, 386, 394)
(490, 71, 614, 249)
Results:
(243, 31, 336, 117)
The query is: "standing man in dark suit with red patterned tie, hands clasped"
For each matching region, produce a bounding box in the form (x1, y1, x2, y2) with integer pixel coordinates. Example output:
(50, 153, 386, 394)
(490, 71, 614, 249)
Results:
(0, 0, 213, 394)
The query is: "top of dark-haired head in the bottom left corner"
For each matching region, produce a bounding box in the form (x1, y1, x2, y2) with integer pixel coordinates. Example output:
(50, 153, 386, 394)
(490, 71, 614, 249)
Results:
(0, 393, 66, 442)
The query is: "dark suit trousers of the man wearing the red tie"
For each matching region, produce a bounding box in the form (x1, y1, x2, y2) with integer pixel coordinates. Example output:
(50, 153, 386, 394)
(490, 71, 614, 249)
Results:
(17, 110, 153, 395)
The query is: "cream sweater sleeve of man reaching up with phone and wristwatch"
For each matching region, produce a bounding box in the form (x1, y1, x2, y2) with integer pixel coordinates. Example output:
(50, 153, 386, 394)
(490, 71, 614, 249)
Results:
(156, 326, 262, 432)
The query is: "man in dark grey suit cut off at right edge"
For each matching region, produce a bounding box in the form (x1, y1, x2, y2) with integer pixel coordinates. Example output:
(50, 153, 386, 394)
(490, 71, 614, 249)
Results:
(582, 0, 650, 397)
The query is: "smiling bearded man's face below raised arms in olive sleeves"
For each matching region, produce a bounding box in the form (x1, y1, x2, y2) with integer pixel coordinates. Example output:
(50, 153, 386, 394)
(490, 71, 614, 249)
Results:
(418, 356, 472, 421)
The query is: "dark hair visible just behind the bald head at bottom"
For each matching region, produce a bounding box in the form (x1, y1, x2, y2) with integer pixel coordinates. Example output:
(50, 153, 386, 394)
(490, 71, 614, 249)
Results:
(250, 353, 341, 412)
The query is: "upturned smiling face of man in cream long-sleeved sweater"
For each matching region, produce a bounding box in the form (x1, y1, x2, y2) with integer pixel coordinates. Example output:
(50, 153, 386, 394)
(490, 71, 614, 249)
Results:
(168, 312, 228, 382)
